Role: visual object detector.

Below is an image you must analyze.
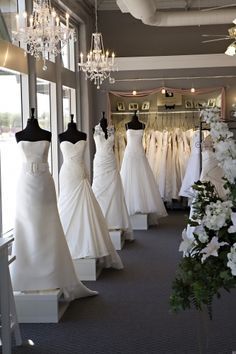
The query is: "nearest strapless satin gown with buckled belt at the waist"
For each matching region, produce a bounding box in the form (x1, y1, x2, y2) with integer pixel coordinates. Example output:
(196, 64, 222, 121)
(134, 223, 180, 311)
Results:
(10, 140, 97, 300)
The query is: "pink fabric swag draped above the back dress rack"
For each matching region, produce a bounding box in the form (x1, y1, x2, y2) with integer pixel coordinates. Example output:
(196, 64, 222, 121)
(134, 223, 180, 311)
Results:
(107, 87, 225, 122)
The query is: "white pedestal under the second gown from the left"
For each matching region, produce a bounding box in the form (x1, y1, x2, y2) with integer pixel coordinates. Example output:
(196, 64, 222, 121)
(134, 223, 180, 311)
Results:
(73, 258, 102, 281)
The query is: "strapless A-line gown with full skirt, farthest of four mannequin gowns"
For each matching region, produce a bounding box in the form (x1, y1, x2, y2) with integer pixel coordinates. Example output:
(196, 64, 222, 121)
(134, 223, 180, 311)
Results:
(120, 129, 167, 217)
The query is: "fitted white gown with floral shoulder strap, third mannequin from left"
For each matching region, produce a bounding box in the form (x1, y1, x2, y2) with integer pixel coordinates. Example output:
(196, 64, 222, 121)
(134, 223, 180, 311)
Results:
(92, 124, 133, 239)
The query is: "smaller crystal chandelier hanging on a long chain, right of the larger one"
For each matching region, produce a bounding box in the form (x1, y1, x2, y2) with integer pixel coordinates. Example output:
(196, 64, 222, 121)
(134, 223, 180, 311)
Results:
(78, 0, 116, 89)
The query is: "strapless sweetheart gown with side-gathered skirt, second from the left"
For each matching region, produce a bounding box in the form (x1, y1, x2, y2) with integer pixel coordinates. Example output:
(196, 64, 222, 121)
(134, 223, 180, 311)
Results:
(58, 140, 123, 269)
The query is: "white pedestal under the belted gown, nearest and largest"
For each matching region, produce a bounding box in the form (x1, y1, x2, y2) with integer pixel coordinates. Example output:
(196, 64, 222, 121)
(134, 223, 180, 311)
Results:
(14, 289, 69, 323)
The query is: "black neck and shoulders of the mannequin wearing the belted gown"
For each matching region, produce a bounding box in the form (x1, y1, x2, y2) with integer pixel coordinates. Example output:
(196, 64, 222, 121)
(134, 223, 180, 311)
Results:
(15, 108, 52, 143)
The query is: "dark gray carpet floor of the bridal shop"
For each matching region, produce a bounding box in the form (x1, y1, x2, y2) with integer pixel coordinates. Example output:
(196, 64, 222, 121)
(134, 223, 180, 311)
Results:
(10, 211, 236, 354)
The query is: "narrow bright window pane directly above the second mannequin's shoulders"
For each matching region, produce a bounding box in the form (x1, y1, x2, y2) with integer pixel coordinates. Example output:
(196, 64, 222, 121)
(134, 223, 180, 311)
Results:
(62, 86, 76, 130)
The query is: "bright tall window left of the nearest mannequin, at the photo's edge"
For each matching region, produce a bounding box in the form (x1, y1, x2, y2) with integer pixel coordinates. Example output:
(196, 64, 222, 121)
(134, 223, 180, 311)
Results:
(0, 71, 22, 233)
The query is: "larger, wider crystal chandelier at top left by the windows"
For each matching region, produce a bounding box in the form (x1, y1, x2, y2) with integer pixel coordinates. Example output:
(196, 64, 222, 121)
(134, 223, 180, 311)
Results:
(12, 0, 75, 70)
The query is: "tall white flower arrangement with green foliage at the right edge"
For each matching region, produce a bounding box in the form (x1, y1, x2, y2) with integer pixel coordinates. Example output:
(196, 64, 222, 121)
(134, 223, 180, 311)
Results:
(170, 108, 236, 318)
